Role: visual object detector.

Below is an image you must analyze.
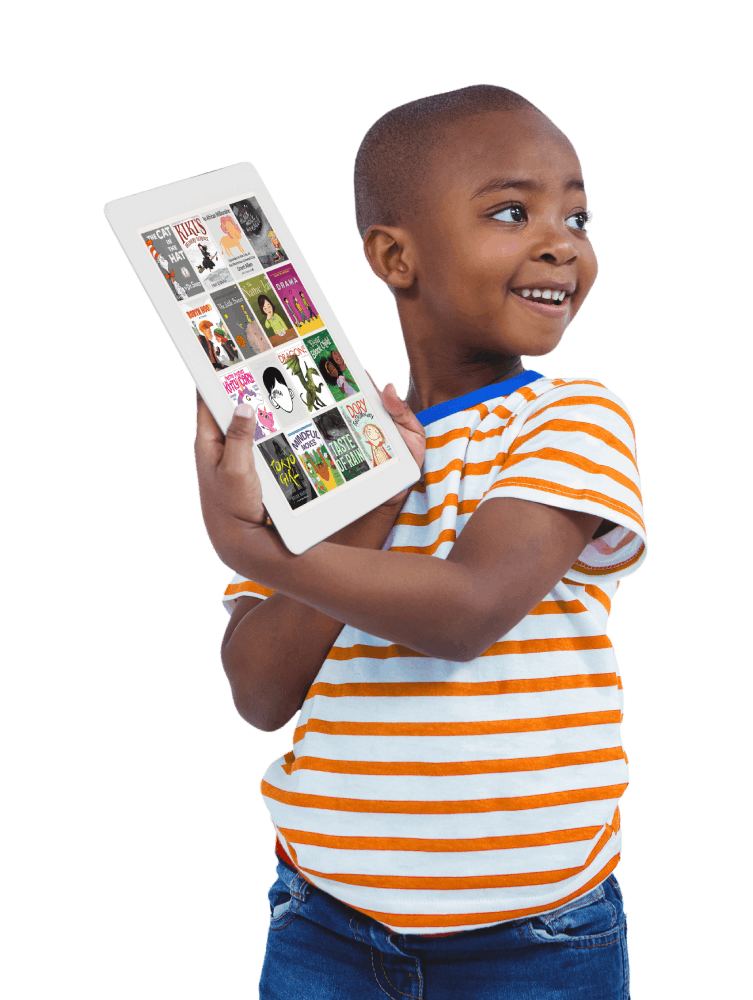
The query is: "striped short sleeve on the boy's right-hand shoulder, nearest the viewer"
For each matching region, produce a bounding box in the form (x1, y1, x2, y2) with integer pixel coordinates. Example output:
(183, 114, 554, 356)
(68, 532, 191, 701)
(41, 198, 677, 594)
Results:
(476, 378, 648, 583)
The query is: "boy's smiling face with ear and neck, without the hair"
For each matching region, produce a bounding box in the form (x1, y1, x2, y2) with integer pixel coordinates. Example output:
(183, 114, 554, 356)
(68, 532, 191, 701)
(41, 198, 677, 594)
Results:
(364, 111, 599, 407)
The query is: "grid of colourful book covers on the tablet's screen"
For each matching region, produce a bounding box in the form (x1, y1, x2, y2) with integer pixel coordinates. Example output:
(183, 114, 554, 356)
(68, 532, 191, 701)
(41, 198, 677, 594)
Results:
(140, 195, 394, 513)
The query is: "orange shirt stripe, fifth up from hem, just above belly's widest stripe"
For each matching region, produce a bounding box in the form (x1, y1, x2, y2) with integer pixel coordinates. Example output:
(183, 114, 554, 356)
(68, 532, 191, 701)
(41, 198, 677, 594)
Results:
(282, 747, 627, 778)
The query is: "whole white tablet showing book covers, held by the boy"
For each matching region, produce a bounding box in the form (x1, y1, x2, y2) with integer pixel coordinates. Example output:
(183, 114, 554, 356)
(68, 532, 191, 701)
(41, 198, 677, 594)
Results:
(104, 160, 421, 555)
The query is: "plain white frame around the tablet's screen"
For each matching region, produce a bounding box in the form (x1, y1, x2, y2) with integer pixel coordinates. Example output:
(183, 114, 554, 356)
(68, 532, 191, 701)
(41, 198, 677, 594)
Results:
(103, 160, 421, 555)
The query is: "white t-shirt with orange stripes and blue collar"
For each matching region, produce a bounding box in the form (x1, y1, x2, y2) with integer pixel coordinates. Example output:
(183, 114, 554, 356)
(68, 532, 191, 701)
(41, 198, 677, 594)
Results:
(222, 369, 648, 936)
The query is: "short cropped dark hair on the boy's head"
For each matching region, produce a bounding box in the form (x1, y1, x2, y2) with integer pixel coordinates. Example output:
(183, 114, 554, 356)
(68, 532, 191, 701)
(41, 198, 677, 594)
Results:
(353, 83, 548, 284)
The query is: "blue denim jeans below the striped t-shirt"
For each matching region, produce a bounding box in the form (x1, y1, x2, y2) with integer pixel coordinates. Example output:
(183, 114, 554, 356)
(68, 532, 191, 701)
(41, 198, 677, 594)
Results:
(259, 858, 630, 1000)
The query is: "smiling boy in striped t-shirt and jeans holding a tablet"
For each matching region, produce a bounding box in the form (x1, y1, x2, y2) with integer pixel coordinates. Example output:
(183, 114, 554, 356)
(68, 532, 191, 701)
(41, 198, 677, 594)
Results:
(192, 84, 648, 1000)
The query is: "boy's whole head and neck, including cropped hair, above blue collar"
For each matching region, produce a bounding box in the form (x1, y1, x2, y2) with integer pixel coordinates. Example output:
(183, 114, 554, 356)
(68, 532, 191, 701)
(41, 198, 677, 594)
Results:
(353, 84, 598, 409)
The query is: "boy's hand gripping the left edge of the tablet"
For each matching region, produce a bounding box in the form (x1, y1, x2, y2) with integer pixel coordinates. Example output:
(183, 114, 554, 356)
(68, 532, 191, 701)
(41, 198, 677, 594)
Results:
(193, 387, 267, 569)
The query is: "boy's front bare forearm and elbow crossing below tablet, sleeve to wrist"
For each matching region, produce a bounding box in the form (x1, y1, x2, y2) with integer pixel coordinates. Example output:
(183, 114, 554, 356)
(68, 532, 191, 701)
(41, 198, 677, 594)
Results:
(225, 497, 612, 662)
